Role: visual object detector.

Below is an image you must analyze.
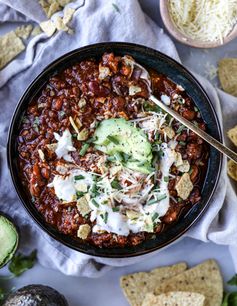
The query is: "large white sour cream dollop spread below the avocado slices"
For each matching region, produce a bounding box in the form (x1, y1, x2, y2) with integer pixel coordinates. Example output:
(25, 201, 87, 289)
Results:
(48, 141, 177, 236)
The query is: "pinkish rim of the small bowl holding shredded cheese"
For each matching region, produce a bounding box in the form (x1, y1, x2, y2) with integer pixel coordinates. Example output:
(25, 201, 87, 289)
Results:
(160, 0, 237, 49)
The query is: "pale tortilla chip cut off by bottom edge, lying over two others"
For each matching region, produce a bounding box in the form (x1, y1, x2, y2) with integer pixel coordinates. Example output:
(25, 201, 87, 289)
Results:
(142, 291, 205, 306)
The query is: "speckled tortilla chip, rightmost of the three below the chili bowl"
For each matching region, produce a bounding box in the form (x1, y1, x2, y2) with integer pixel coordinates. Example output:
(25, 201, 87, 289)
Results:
(155, 260, 223, 306)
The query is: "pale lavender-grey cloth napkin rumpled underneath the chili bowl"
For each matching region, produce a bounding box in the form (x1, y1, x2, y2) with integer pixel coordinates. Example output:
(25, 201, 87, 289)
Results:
(0, 0, 237, 277)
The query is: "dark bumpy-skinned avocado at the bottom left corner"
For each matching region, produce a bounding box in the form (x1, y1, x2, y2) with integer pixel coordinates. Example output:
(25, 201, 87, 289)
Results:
(2, 285, 68, 306)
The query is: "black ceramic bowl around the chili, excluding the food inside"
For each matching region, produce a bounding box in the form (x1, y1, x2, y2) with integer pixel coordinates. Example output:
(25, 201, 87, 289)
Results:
(7, 42, 222, 258)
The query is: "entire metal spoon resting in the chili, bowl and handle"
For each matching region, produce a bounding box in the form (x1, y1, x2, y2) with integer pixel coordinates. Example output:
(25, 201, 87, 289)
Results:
(133, 62, 237, 163)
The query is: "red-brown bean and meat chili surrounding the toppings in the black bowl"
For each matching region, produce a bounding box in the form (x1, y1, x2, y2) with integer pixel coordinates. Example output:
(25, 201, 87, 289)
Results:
(18, 53, 208, 247)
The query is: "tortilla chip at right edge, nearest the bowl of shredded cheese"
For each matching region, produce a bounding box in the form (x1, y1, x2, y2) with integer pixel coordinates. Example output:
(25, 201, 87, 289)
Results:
(218, 58, 237, 96)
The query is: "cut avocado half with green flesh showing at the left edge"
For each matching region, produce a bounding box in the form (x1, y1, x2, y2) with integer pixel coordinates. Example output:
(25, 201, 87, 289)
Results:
(0, 215, 19, 268)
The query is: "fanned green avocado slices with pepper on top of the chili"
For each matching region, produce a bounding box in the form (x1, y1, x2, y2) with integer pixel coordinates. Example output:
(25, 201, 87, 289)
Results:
(94, 118, 152, 173)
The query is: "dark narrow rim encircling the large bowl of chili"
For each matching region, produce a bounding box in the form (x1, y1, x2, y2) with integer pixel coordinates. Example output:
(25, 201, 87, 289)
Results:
(7, 42, 223, 258)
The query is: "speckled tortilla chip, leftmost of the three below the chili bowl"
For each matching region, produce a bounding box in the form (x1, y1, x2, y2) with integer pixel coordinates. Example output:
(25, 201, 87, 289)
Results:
(120, 263, 187, 306)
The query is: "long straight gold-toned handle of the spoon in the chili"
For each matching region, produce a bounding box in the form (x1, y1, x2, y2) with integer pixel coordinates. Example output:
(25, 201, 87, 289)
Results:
(149, 95, 237, 163)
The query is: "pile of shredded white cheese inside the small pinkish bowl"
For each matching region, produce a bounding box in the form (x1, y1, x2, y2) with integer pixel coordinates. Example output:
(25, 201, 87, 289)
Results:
(168, 0, 237, 43)
